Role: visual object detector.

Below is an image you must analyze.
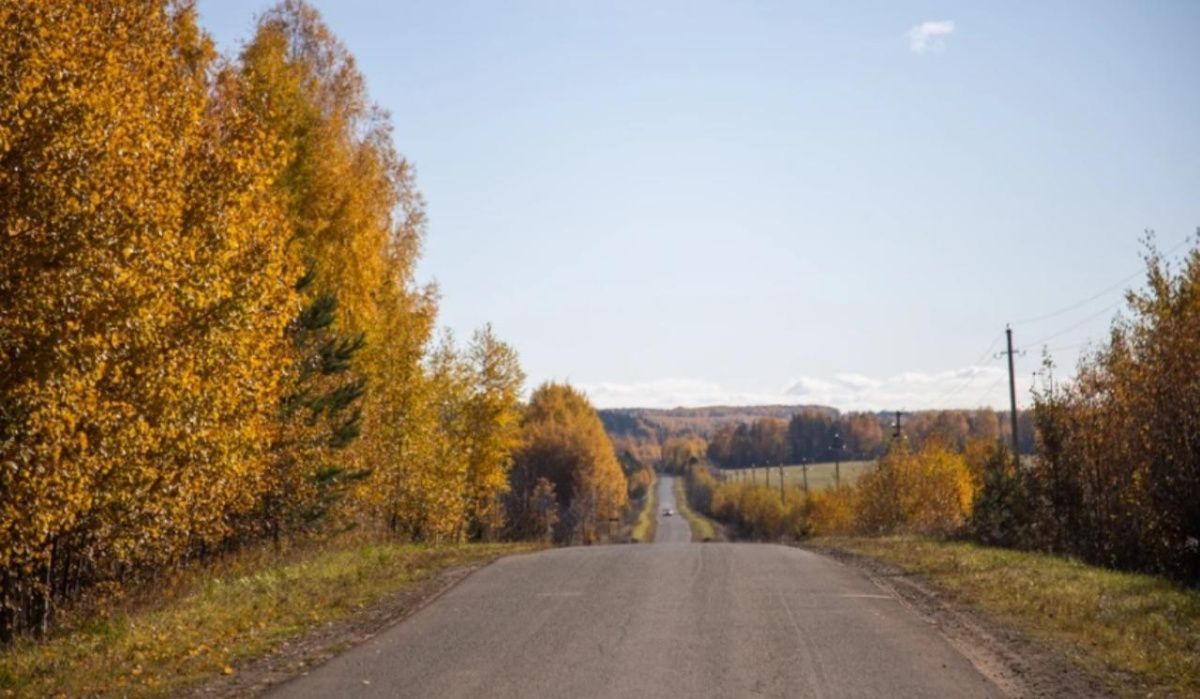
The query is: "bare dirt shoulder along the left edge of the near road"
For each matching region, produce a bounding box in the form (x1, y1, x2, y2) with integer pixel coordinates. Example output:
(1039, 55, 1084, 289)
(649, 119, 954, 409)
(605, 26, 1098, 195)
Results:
(182, 563, 486, 699)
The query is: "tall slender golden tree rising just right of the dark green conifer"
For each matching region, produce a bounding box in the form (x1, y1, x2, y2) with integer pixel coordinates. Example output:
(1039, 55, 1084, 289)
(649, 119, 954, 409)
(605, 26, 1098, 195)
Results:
(241, 0, 441, 537)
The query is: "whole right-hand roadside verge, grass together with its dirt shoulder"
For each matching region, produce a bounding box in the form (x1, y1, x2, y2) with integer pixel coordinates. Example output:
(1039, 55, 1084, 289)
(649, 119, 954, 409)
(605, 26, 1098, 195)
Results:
(803, 537, 1200, 697)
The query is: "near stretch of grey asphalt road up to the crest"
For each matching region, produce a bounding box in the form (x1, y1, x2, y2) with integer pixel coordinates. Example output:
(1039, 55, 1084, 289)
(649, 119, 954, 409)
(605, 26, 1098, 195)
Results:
(274, 543, 1000, 699)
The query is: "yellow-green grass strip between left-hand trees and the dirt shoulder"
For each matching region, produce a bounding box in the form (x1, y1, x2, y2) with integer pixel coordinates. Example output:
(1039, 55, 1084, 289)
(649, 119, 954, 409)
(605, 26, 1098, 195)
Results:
(0, 544, 536, 697)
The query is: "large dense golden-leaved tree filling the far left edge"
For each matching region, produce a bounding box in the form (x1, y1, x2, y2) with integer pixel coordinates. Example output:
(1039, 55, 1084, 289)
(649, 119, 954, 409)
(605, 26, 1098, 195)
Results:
(0, 0, 296, 634)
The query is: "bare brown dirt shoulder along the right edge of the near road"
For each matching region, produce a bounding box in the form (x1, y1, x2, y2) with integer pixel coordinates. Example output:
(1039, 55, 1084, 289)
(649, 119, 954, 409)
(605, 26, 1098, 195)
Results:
(803, 545, 1114, 697)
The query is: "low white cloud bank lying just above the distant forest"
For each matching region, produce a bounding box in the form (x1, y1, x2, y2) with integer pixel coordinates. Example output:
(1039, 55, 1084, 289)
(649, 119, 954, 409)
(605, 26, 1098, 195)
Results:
(578, 366, 1008, 410)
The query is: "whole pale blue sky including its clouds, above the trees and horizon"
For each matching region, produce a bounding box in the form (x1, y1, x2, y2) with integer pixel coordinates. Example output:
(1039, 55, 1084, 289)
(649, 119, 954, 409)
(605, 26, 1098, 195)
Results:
(199, 0, 1200, 408)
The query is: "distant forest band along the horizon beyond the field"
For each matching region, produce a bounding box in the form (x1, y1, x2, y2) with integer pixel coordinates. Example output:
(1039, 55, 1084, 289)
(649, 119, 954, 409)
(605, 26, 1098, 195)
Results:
(600, 405, 1034, 470)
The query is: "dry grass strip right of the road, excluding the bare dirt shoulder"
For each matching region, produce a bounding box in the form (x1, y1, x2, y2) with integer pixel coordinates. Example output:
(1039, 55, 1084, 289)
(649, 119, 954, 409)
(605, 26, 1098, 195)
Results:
(811, 537, 1200, 697)
